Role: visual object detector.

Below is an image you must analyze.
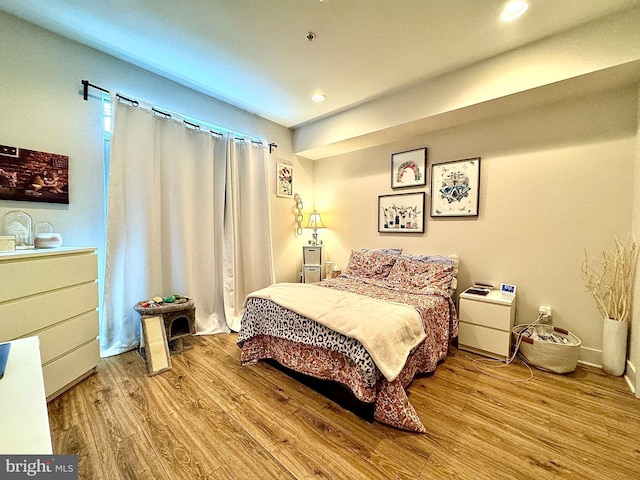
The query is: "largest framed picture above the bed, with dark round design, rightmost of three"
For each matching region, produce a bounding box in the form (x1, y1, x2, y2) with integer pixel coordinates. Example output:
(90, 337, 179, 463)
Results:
(431, 157, 480, 217)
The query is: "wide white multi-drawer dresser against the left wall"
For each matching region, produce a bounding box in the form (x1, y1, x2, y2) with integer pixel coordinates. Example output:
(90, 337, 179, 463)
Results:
(0, 247, 100, 401)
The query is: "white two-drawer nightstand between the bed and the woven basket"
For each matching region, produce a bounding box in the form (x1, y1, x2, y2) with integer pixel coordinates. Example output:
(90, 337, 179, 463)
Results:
(458, 290, 516, 359)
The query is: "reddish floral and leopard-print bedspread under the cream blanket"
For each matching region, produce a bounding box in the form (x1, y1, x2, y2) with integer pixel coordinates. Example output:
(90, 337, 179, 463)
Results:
(238, 274, 458, 432)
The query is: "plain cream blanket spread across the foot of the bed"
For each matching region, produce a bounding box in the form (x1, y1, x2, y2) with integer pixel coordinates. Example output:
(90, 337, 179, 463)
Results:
(245, 283, 426, 381)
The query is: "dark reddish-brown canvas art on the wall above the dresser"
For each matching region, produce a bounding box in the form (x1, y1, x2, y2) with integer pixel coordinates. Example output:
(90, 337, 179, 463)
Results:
(0, 145, 69, 203)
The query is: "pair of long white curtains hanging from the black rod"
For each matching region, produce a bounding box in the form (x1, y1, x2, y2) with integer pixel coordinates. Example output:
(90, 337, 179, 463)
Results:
(100, 98, 273, 356)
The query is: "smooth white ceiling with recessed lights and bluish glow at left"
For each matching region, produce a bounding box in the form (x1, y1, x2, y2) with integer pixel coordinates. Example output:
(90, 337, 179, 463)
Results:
(0, 0, 640, 127)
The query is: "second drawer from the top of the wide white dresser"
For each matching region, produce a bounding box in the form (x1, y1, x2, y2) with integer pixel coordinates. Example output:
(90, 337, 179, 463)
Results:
(0, 280, 98, 342)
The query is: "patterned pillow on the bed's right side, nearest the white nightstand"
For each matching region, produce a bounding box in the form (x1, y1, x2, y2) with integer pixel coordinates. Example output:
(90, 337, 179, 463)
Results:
(387, 255, 454, 290)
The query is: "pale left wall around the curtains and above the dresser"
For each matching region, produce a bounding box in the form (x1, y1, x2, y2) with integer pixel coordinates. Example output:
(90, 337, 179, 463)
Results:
(0, 13, 312, 284)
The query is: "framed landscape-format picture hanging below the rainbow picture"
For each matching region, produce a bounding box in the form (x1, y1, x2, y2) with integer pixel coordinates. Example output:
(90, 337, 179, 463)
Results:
(378, 192, 425, 233)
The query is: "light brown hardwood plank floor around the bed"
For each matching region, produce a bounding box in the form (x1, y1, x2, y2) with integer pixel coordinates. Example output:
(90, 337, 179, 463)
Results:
(49, 334, 640, 480)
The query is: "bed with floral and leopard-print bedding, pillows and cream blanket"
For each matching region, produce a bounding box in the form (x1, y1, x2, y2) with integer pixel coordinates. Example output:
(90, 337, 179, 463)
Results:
(237, 249, 458, 433)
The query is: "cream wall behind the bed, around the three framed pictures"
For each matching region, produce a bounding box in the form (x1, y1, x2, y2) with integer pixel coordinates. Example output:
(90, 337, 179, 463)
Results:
(315, 87, 636, 363)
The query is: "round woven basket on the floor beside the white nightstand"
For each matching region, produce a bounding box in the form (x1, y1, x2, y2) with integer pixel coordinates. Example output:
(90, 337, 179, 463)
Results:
(512, 325, 582, 373)
